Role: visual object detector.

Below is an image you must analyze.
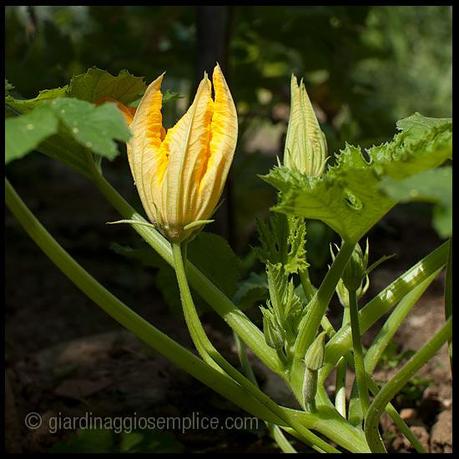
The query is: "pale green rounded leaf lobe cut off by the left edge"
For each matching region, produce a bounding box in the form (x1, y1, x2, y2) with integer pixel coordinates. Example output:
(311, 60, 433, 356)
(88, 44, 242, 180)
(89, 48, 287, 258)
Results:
(5, 107, 58, 164)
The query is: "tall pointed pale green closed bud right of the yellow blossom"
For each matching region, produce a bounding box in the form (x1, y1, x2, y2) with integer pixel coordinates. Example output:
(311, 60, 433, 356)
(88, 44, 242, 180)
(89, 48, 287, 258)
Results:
(284, 75, 327, 177)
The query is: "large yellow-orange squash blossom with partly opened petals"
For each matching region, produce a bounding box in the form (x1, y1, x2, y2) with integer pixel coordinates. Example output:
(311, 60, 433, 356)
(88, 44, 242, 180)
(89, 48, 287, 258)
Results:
(128, 65, 237, 242)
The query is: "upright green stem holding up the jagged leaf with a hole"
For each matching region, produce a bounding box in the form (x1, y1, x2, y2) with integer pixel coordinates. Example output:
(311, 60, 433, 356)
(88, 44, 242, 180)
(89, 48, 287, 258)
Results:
(291, 242, 355, 400)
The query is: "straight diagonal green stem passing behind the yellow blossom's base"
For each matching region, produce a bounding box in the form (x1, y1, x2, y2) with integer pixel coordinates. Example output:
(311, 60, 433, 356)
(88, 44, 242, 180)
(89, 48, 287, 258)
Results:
(90, 174, 283, 375)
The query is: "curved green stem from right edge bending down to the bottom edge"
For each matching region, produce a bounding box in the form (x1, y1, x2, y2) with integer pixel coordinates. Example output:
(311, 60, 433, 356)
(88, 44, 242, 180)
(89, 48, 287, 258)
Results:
(365, 317, 452, 453)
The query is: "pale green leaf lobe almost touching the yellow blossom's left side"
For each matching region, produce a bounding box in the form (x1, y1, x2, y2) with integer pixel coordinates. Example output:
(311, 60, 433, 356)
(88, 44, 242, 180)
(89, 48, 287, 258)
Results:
(51, 98, 130, 159)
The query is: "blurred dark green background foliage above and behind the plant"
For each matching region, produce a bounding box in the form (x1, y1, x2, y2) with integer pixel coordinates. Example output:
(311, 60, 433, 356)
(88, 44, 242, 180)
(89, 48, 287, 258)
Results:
(5, 6, 452, 259)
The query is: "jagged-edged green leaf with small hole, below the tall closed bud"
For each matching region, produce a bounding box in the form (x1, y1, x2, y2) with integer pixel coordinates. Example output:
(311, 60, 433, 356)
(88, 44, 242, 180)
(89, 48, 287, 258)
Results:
(263, 115, 452, 242)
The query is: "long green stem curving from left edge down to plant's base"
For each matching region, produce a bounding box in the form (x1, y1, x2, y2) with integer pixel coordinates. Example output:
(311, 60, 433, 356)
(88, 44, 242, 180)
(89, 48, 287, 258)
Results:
(5, 179, 282, 422)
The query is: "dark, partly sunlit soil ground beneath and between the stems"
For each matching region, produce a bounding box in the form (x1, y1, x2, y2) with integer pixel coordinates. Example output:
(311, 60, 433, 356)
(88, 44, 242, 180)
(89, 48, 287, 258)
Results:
(5, 158, 452, 452)
